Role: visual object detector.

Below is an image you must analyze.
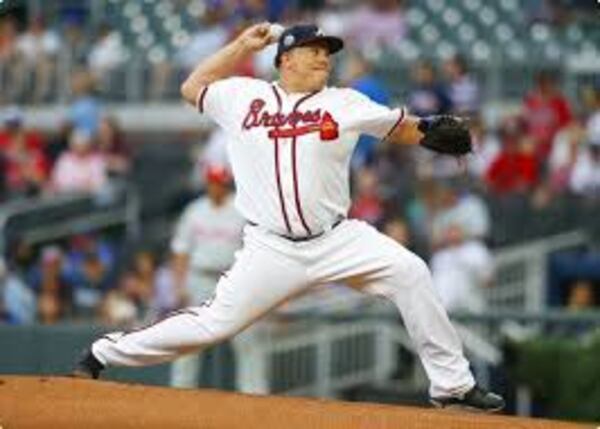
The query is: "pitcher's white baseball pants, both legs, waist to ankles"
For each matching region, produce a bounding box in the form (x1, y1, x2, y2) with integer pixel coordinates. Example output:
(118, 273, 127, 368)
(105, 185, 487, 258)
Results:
(92, 220, 475, 397)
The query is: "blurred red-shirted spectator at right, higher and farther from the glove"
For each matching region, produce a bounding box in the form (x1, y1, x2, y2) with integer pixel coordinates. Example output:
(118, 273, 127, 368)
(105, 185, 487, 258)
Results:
(523, 71, 572, 162)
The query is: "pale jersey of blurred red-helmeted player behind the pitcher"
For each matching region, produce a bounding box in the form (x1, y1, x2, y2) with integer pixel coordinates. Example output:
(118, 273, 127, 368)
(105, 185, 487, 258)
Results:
(171, 197, 245, 272)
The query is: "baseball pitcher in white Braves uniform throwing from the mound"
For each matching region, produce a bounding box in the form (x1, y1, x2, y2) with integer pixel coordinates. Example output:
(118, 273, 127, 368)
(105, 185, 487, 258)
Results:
(76, 23, 504, 412)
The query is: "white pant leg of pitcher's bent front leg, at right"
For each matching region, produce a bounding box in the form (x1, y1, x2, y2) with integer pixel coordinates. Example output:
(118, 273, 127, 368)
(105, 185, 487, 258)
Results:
(318, 221, 475, 397)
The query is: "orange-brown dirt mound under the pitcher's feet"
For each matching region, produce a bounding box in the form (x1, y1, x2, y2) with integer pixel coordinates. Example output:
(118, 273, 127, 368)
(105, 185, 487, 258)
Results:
(0, 376, 594, 429)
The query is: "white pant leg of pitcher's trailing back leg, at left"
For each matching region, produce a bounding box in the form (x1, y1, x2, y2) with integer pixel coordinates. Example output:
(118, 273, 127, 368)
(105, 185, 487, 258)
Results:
(92, 234, 307, 366)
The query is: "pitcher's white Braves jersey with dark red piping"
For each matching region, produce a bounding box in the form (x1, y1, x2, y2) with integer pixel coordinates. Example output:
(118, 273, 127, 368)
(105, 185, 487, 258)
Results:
(197, 77, 405, 237)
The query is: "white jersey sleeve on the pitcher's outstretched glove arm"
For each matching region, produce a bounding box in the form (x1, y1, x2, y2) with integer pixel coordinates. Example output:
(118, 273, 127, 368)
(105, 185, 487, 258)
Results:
(344, 89, 406, 139)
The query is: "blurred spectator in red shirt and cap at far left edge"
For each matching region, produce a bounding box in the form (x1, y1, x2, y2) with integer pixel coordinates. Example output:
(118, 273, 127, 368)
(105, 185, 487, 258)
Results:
(0, 108, 48, 198)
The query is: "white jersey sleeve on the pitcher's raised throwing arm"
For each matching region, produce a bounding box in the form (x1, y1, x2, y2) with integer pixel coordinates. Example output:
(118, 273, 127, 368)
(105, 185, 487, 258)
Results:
(196, 77, 261, 130)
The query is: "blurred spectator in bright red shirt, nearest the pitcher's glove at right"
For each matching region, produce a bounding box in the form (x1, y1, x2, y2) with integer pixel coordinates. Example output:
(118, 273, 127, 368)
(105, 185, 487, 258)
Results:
(485, 114, 539, 195)
